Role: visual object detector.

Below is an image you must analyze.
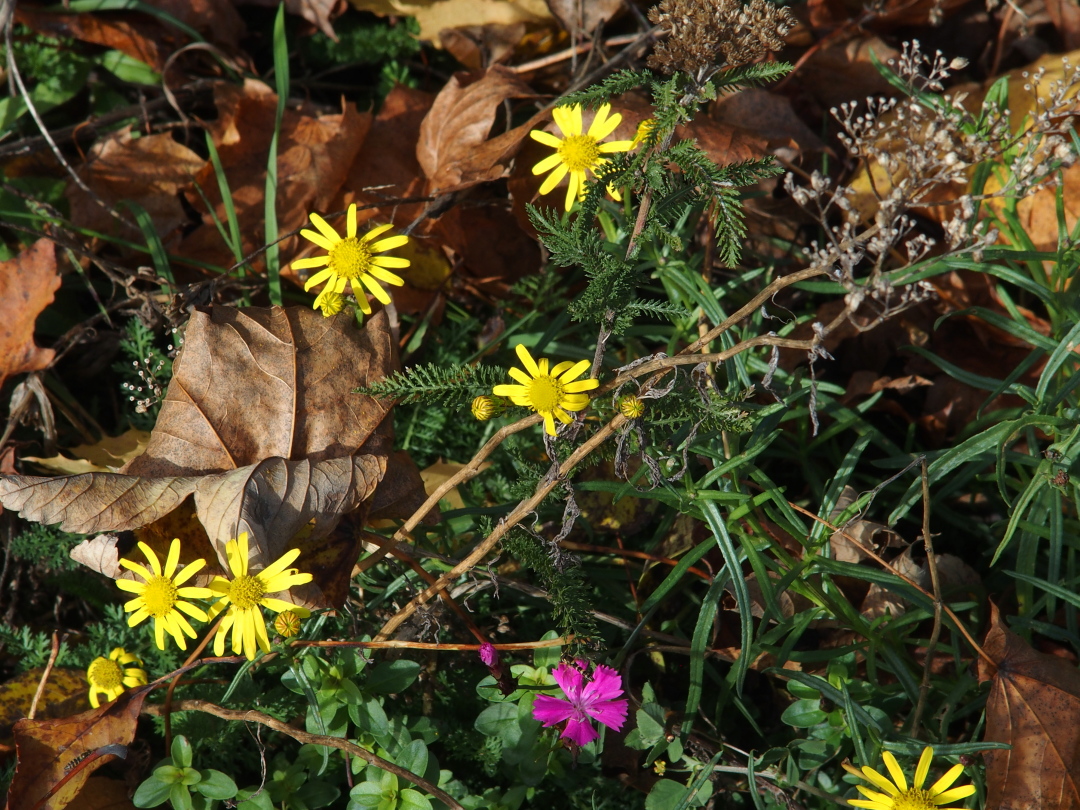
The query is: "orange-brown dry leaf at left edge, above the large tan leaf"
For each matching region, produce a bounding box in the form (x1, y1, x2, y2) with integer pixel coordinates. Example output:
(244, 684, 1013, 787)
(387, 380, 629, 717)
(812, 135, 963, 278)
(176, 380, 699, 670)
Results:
(0, 239, 60, 388)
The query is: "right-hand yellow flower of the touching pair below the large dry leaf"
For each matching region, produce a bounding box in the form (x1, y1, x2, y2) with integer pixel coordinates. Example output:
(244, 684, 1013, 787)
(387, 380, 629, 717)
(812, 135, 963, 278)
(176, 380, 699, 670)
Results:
(208, 531, 311, 661)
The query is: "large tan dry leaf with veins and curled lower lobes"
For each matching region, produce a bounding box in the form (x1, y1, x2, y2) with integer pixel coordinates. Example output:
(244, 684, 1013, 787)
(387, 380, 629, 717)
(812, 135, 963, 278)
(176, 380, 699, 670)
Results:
(0, 307, 409, 606)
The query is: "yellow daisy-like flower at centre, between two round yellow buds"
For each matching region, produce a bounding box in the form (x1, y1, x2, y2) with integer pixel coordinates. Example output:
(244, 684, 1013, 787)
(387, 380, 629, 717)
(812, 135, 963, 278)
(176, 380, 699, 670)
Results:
(491, 343, 600, 436)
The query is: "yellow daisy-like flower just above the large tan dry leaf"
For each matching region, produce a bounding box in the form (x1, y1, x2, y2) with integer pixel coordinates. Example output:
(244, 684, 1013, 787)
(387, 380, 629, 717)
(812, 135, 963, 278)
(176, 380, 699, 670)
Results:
(293, 203, 410, 315)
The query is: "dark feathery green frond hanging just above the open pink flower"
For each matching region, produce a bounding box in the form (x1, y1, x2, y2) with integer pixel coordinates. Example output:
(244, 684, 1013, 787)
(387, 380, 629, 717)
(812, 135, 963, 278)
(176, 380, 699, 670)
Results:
(502, 528, 597, 654)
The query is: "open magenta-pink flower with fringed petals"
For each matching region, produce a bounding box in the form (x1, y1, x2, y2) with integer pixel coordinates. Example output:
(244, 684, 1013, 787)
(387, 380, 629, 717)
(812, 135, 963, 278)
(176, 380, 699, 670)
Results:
(532, 661, 627, 745)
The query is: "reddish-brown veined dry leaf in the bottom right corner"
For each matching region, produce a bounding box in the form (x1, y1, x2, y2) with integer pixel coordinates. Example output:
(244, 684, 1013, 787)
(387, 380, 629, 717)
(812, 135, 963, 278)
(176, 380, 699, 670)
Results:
(978, 604, 1080, 810)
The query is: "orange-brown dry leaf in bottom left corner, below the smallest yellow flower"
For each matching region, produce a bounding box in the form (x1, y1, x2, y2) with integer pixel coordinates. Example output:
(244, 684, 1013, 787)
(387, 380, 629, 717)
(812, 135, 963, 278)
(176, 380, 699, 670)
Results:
(8, 687, 150, 810)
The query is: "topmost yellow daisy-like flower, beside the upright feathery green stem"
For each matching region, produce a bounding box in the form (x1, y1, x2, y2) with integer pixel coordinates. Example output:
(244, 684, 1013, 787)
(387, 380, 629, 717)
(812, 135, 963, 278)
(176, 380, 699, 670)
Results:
(529, 104, 634, 211)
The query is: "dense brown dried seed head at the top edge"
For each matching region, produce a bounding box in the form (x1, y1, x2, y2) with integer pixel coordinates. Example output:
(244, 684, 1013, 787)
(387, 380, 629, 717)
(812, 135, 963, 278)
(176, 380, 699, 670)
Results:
(649, 0, 795, 78)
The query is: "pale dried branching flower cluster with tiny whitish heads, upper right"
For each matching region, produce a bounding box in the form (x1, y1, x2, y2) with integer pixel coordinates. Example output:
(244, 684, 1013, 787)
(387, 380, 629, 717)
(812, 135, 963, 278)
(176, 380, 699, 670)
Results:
(784, 41, 1080, 339)
